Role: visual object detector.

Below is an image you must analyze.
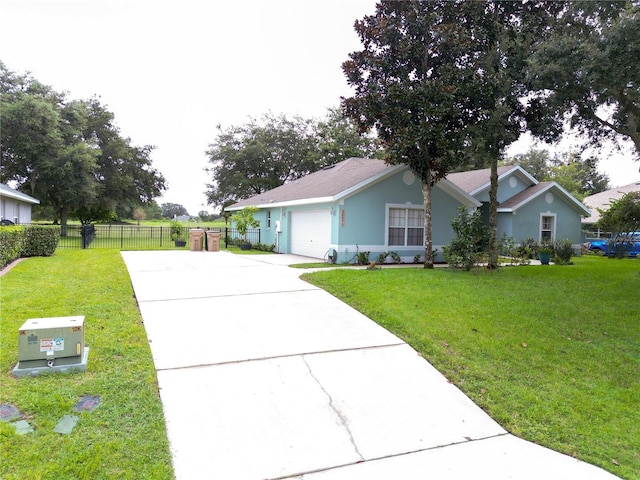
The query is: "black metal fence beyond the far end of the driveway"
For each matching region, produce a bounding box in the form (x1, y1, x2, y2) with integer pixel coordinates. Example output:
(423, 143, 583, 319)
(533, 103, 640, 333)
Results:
(58, 225, 260, 250)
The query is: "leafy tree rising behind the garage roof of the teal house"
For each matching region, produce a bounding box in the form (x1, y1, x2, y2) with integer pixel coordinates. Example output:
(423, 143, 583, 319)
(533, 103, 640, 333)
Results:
(206, 110, 380, 207)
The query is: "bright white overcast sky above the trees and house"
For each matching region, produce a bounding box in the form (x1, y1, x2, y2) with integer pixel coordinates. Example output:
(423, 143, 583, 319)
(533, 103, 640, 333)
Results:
(0, 0, 640, 215)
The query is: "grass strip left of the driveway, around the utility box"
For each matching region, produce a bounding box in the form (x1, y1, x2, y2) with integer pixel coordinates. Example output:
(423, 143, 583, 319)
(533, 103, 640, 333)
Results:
(0, 250, 173, 480)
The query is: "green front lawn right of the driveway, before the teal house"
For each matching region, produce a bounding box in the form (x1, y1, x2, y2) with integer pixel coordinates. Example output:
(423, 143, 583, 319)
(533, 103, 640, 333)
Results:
(303, 257, 640, 479)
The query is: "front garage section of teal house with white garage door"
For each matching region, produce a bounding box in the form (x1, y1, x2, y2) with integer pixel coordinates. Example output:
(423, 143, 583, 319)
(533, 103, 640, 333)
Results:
(226, 158, 480, 263)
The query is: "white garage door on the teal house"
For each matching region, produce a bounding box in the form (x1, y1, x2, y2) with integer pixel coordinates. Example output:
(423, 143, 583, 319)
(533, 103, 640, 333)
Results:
(291, 210, 331, 258)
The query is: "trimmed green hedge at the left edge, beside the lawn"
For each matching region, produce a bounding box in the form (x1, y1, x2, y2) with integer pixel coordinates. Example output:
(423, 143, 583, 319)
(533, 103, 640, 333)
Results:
(0, 225, 60, 268)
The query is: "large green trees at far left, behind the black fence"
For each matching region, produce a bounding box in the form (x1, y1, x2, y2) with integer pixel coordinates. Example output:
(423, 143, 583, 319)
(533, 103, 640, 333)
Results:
(0, 62, 166, 224)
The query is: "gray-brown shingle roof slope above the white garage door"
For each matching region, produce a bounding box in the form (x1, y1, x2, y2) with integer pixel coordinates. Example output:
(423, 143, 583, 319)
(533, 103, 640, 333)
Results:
(229, 158, 398, 209)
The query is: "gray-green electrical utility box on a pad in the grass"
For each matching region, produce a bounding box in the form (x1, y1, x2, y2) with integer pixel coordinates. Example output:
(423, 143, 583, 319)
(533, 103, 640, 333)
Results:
(13, 315, 88, 375)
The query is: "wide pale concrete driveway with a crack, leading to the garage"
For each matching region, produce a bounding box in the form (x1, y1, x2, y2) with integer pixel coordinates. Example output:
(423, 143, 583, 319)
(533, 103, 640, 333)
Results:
(122, 251, 617, 480)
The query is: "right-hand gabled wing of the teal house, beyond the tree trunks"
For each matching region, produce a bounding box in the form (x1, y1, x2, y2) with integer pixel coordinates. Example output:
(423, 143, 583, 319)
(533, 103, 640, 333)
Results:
(447, 165, 591, 249)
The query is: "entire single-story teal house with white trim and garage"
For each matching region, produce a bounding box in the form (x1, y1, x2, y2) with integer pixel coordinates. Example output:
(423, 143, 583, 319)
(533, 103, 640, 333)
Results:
(226, 158, 589, 263)
